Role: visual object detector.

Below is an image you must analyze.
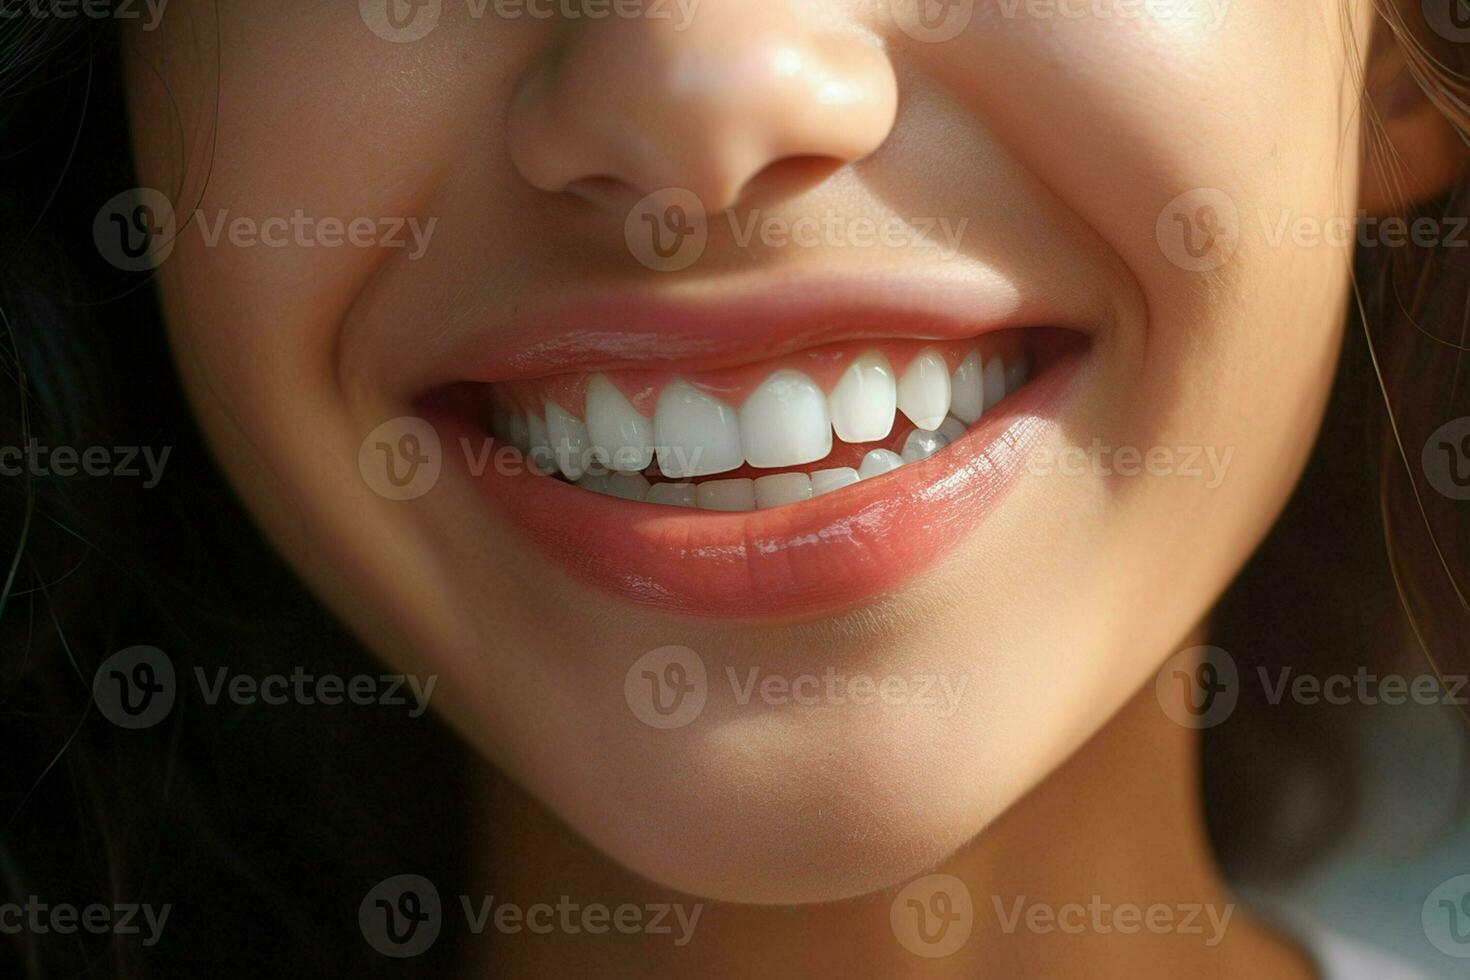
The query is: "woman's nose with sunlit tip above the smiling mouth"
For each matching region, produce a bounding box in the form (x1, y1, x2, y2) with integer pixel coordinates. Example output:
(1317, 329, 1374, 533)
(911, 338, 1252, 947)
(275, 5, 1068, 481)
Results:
(507, 0, 898, 213)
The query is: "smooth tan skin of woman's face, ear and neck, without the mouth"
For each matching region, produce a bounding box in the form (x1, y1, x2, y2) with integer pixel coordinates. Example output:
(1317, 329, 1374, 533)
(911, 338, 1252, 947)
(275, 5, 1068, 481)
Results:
(126, 0, 1463, 977)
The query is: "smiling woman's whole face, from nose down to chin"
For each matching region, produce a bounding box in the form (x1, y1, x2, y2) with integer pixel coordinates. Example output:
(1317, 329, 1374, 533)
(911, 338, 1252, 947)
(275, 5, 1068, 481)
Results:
(128, 0, 1369, 902)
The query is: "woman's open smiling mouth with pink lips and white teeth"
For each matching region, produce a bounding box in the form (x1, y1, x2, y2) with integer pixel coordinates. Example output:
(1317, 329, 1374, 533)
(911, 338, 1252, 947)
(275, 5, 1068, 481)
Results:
(419, 283, 1088, 620)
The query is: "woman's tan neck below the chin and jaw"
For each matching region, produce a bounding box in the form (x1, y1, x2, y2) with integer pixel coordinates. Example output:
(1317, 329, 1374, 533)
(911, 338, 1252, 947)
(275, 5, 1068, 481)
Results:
(448, 669, 1313, 979)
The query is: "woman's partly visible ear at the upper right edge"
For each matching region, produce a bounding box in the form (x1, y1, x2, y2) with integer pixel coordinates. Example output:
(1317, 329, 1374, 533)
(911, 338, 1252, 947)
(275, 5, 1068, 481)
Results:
(1358, 22, 1470, 217)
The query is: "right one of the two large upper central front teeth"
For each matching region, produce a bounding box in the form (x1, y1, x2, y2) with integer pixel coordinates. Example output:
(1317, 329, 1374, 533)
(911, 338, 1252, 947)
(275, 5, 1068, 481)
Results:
(739, 370, 832, 467)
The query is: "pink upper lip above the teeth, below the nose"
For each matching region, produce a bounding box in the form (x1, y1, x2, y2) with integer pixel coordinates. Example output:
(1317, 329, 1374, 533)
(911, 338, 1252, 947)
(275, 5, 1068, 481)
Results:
(426, 275, 1089, 383)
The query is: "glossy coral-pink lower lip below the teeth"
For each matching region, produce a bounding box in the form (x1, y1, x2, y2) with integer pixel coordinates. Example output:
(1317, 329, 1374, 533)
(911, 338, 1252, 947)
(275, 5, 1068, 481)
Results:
(434, 357, 1080, 620)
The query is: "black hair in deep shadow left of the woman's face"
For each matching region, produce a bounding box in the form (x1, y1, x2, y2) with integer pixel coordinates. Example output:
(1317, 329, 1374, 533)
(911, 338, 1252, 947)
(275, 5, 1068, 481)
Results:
(0, 18, 466, 977)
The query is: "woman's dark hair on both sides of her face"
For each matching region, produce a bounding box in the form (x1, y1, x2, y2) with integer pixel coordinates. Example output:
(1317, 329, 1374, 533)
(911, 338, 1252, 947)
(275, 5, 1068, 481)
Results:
(0, 6, 1470, 977)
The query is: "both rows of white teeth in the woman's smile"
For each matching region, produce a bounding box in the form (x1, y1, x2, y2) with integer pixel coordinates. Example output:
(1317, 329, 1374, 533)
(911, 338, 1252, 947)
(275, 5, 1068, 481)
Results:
(540, 348, 1030, 511)
